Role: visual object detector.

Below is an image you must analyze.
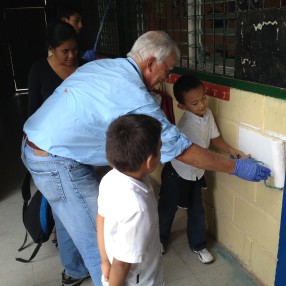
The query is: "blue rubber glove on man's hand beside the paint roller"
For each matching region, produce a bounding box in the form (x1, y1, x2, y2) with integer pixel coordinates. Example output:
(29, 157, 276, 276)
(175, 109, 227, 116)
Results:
(232, 158, 271, 182)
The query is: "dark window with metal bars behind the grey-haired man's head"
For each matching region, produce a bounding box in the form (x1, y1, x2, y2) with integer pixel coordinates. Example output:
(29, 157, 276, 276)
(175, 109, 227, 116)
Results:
(95, 0, 286, 81)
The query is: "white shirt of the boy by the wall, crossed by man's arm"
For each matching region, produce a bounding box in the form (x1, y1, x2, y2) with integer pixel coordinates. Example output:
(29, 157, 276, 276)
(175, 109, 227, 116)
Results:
(171, 108, 220, 181)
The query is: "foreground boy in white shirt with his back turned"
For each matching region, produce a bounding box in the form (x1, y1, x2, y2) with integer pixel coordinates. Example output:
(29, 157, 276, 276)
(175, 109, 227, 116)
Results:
(97, 114, 164, 286)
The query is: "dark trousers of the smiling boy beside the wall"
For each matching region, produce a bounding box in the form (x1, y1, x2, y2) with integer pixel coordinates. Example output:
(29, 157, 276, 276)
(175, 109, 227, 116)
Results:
(158, 163, 206, 250)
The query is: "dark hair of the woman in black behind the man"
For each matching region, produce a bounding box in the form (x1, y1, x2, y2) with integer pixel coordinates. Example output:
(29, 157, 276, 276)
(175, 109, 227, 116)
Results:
(47, 21, 78, 48)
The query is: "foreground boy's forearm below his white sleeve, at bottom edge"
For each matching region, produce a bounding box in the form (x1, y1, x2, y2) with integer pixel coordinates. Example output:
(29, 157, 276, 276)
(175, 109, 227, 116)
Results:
(109, 258, 131, 286)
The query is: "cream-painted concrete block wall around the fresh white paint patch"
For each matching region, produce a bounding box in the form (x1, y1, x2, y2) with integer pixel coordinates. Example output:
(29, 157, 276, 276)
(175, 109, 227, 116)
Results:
(153, 81, 286, 286)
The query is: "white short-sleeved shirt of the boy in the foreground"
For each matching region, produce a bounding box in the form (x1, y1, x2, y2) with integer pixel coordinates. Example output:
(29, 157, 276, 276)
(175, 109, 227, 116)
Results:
(98, 169, 164, 286)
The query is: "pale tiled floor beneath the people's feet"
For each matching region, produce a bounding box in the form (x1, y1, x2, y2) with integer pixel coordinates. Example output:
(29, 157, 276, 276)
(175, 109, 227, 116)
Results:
(0, 190, 264, 286)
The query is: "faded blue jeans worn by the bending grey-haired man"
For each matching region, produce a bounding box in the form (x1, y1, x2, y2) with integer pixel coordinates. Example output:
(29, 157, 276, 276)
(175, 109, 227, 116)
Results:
(22, 140, 102, 286)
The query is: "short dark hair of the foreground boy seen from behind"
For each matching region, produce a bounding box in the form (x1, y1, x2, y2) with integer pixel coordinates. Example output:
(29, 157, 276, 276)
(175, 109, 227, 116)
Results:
(106, 114, 162, 172)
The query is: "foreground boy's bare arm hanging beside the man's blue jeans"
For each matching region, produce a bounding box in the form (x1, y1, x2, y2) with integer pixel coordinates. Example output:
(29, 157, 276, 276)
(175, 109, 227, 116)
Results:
(96, 214, 111, 281)
